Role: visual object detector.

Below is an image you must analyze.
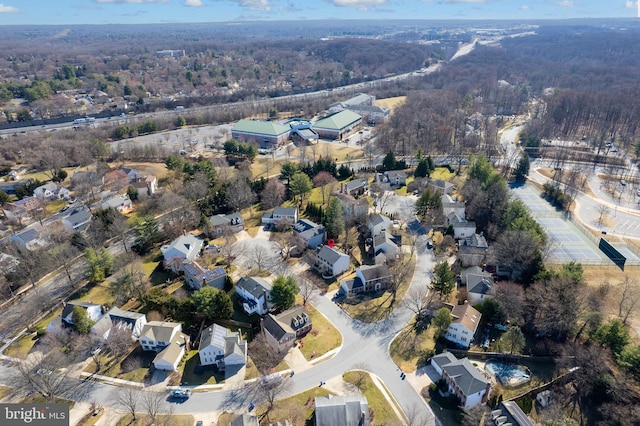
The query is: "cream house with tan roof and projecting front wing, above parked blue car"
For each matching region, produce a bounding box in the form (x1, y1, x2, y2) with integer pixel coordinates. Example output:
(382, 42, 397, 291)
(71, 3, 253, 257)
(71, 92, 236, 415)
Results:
(139, 321, 189, 371)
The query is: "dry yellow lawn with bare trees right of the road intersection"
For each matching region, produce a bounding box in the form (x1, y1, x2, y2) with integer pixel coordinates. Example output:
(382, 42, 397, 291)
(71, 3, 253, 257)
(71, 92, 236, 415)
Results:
(389, 326, 436, 372)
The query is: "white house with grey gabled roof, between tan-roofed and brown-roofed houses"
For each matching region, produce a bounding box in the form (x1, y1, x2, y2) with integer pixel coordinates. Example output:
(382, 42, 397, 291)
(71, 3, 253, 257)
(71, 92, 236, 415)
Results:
(198, 324, 247, 370)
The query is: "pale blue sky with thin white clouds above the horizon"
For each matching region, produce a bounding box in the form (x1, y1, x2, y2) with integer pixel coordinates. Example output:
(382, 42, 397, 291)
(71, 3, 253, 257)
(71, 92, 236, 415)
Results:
(0, 0, 640, 25)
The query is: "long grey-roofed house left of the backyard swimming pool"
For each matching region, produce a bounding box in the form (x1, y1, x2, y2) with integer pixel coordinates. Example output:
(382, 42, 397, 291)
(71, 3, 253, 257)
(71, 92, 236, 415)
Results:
(431, 353, 492, 409)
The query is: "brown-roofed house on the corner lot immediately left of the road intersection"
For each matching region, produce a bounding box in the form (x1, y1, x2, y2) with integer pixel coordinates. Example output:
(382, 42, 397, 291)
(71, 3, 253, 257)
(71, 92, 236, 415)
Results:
(262, 305, 312, 352)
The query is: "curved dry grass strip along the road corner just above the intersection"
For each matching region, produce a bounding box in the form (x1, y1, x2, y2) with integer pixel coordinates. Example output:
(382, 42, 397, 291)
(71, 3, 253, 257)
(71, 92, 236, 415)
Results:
(340, 258, 416, 322)
